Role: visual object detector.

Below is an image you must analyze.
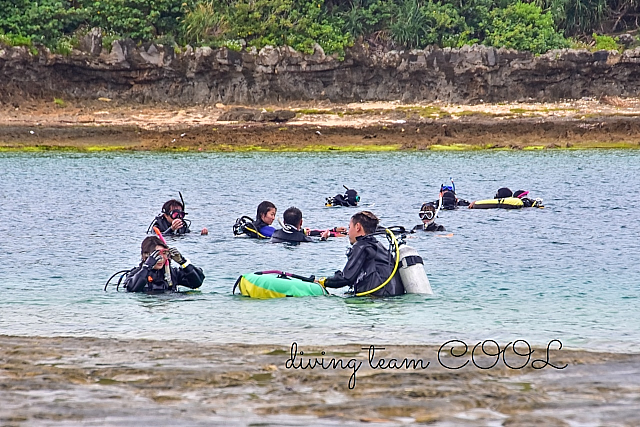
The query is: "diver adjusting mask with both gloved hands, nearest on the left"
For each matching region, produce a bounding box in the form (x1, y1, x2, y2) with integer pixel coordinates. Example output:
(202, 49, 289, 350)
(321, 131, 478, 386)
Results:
(124, 236, 204, 293)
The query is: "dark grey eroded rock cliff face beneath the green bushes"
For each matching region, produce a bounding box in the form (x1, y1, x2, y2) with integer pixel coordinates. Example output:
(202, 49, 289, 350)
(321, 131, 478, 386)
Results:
(0, 40, 640, 105)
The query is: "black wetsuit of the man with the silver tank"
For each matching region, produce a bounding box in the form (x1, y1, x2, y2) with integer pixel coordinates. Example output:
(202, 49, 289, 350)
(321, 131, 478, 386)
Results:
(324, 236, 404, 297)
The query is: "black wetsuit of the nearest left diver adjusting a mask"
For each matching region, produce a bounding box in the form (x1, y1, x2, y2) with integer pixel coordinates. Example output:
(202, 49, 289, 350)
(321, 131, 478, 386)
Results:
(124, 264, 204, 293)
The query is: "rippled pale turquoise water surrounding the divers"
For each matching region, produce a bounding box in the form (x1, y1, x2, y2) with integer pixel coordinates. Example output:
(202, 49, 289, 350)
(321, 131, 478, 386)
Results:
(0, 150, 640, 351)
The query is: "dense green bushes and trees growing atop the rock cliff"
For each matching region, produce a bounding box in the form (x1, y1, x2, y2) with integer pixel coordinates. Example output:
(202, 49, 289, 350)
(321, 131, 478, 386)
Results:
(0, 0, 640, 55)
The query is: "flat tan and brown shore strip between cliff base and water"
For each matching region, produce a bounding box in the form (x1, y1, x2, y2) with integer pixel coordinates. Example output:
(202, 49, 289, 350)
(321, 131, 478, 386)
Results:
(0, 97, 640, 152)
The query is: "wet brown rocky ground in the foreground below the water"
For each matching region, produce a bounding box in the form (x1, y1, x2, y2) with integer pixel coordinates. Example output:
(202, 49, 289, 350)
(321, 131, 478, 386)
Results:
(0, 335, 640, 426)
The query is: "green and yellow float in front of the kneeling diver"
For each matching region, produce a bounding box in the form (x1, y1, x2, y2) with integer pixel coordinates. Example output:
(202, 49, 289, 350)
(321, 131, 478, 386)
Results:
(232, 270, 329, 299)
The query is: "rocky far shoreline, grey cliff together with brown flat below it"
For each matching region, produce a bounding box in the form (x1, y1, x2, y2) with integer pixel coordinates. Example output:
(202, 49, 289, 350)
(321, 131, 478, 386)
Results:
(0, 38, 640, 151)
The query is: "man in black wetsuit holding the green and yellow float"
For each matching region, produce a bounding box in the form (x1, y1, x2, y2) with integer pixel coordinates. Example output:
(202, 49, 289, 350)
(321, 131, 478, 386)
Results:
(317, 211, 404, 297)
